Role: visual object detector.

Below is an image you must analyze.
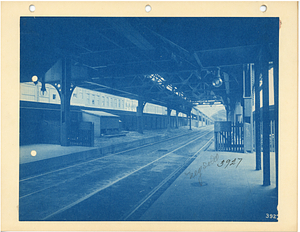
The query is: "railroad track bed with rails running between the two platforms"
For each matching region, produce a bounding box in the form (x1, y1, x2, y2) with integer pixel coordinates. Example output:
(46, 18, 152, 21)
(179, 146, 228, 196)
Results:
(20, 130, 213, 221)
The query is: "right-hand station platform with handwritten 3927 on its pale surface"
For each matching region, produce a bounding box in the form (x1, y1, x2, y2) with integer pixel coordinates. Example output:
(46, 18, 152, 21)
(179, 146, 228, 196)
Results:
(140, 144, 277, 222)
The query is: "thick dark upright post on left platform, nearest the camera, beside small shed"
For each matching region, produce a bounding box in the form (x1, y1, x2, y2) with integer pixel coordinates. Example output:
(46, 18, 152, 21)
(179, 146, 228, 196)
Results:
(60, 58, 71, 146)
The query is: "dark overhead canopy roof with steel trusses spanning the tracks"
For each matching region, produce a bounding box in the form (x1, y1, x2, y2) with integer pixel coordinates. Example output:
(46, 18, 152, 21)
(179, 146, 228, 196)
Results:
(20, 17, 279, 112)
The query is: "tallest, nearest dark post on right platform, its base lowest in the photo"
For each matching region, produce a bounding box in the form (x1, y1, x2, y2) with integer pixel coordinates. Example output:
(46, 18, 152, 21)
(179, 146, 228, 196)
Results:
(261, 45, 271, 186)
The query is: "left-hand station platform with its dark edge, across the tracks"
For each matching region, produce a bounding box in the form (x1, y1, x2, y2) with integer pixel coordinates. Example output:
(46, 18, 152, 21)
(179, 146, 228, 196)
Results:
(19, 125, 212, 178)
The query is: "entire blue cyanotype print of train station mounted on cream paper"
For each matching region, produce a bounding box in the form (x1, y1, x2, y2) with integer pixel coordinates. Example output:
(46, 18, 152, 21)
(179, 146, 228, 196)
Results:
(19, 15, 281, 222)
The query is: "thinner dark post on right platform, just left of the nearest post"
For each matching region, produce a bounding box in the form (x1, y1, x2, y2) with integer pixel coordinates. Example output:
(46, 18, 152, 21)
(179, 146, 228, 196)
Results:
(254, 64, 261, 170)
